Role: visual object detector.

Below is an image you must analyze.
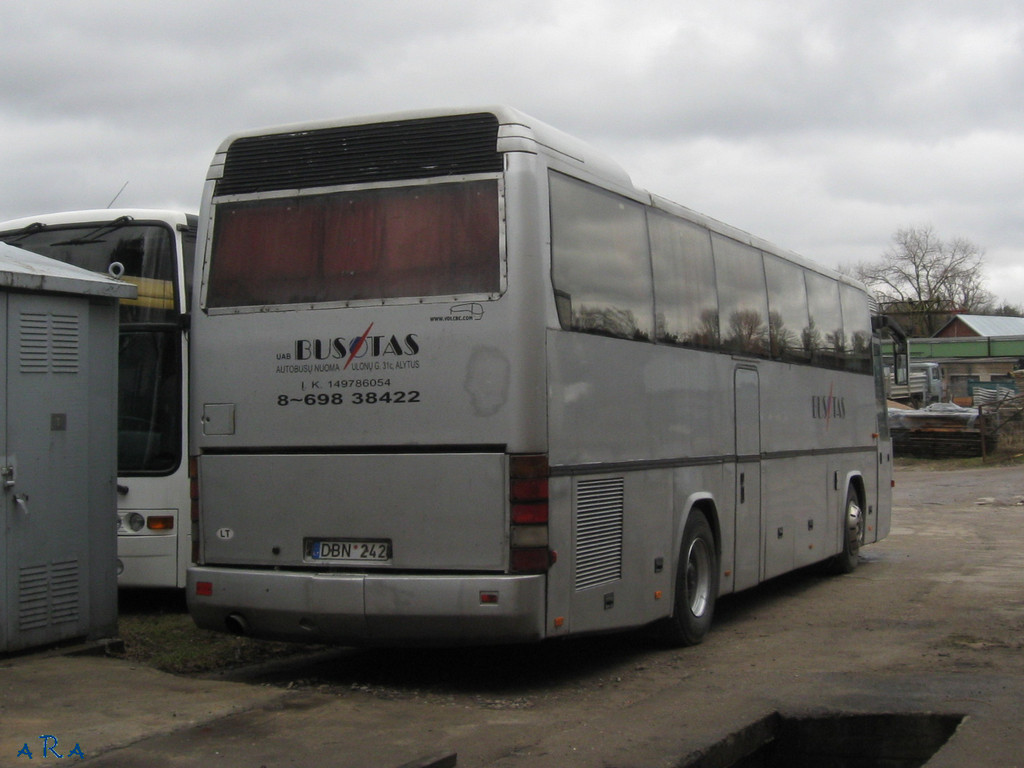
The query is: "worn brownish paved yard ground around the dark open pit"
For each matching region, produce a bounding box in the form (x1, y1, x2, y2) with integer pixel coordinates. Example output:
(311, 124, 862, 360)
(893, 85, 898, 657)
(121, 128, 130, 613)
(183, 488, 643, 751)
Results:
(6, 468, 1024, 768)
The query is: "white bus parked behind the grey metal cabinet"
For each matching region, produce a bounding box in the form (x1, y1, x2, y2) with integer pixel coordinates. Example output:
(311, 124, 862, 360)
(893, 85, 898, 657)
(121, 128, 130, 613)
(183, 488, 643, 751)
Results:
(0, 209, 198, 589)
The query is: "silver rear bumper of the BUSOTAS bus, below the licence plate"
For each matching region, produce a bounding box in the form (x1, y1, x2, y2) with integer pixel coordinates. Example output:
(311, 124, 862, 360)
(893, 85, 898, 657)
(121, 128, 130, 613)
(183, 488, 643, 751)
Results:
(187, 566, 545, 645)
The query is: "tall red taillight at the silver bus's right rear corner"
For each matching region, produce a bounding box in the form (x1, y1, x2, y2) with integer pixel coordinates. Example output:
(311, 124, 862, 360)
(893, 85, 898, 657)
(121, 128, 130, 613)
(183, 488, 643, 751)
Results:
(509, 454, 554, 573)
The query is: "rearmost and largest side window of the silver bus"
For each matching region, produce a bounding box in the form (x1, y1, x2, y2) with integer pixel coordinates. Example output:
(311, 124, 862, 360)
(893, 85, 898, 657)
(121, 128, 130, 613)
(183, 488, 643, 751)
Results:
(550, 173, 653, 339)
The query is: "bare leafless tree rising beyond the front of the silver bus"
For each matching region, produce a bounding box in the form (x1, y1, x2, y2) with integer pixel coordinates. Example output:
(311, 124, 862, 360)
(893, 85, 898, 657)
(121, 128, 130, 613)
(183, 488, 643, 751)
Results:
(851, 225, 994, 336)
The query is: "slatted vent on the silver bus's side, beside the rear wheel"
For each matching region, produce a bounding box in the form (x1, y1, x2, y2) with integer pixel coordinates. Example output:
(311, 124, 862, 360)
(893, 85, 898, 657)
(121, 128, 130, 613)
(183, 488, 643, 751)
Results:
(575, 477, 625, 591)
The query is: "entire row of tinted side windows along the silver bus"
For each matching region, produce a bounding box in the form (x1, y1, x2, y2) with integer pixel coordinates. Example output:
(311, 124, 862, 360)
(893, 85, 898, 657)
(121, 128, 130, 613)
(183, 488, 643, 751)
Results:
(550, 173, 872, 373)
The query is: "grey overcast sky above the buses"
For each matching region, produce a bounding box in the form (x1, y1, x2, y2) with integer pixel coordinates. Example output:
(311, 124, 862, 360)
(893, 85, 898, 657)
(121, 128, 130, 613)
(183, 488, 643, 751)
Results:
(0, 0, 1024, 305)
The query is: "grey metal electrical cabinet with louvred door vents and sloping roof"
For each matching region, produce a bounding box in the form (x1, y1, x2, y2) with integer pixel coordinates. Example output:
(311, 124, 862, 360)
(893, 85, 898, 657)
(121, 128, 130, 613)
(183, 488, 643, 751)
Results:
(0, 243, 136, 652)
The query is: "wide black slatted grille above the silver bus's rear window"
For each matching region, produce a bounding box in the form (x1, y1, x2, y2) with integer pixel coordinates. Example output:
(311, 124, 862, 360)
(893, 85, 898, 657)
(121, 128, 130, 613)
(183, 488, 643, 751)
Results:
(216, 114, 503, 195)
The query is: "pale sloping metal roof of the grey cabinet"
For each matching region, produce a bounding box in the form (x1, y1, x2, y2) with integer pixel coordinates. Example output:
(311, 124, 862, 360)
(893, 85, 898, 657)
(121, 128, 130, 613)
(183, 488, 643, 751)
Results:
(0, 243, 138, 299)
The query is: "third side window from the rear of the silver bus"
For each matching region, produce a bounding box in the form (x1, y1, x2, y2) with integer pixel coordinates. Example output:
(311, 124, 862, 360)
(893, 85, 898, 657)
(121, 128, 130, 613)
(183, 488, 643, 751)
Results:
(712, 234, 768, 356)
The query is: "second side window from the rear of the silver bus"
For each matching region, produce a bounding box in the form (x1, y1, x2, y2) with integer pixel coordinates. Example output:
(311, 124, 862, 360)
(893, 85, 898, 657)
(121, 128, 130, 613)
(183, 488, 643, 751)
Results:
(648, 213, 720, 349)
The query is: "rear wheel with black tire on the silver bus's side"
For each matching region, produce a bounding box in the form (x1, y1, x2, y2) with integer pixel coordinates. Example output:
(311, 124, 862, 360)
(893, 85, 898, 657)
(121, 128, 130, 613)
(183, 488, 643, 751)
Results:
(663, 510, 718, 646)
